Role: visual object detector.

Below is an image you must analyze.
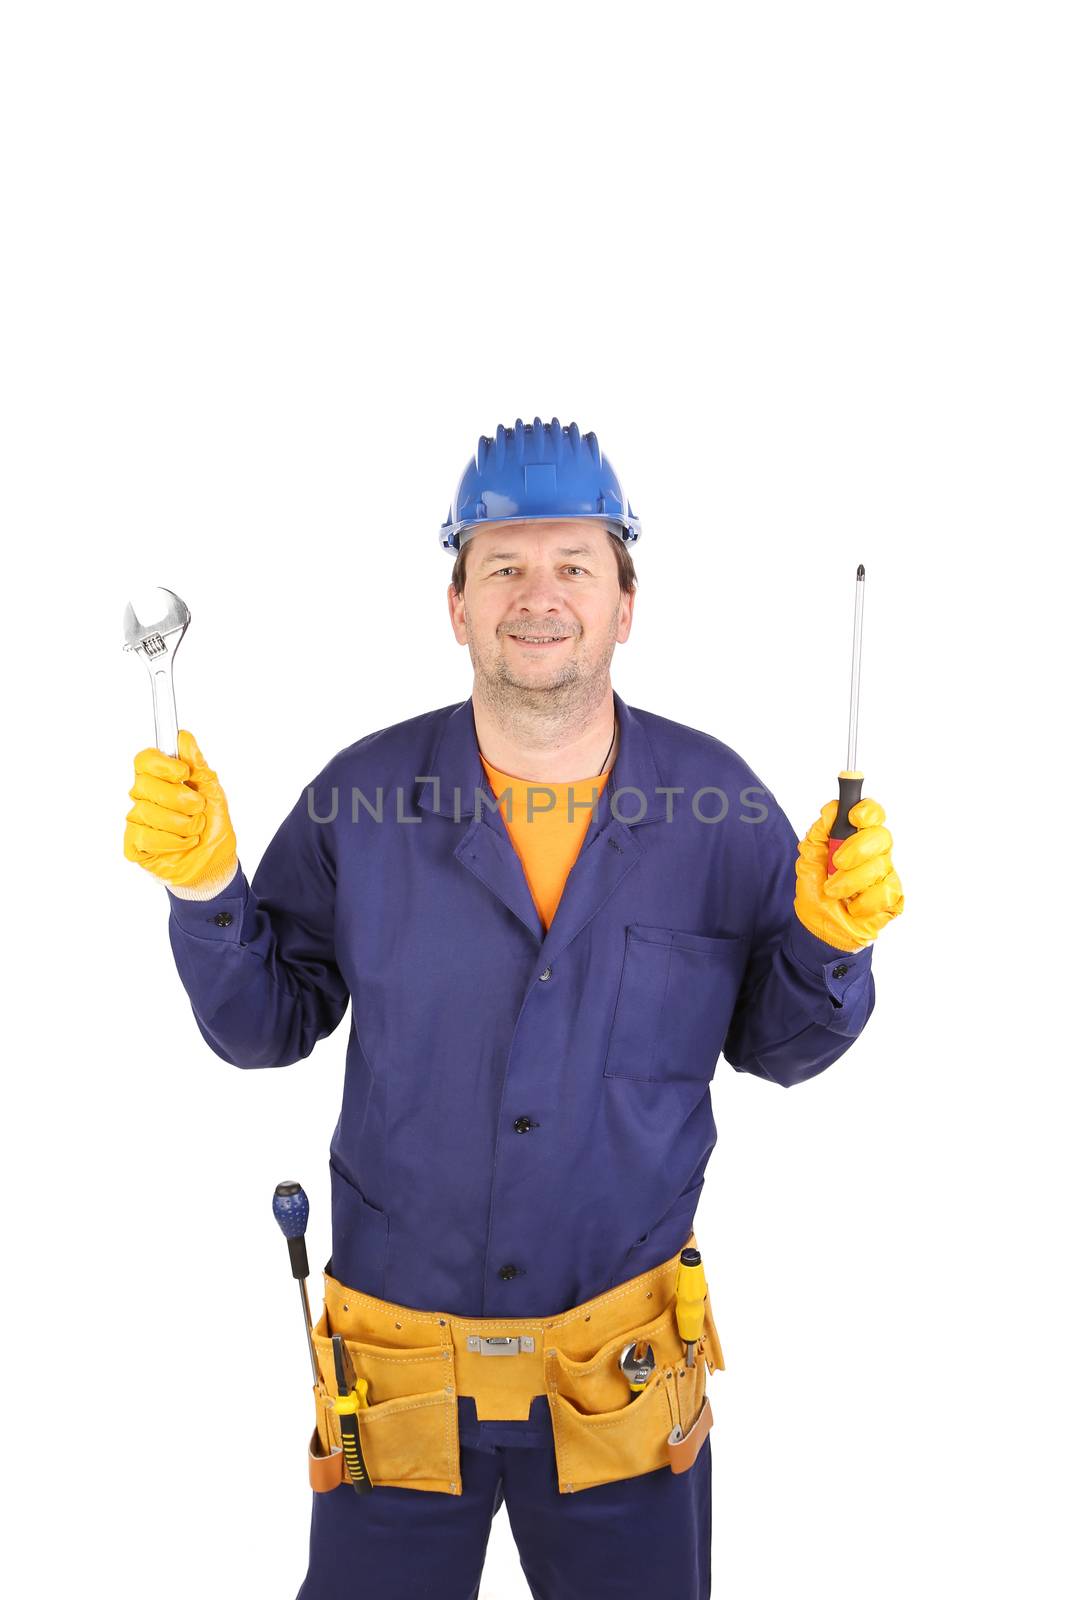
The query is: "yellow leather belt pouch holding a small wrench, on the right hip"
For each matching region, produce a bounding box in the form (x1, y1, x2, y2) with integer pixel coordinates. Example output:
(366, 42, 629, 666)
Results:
(545, 1258, 723, 1494)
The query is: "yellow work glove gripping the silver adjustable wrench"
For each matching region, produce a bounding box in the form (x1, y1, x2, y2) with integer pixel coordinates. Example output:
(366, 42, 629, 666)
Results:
(125, 728, 237, 899)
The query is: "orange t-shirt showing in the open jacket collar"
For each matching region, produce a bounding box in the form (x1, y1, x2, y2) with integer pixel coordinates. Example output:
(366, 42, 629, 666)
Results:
(478, 750, 614, 933)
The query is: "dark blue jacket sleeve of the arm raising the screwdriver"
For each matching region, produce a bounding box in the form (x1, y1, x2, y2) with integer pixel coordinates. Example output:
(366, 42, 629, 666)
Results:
(723, 790, 875, 1086)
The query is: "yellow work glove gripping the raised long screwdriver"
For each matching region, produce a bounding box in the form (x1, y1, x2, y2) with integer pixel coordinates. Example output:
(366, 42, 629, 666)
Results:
(793, 800, 904, 950)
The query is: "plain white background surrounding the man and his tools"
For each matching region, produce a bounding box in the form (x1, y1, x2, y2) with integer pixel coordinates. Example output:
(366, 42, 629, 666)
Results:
(0, 0, 1067, 1600)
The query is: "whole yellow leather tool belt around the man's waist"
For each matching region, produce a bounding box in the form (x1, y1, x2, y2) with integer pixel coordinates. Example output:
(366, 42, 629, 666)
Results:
(309, 1235, 723, 1494)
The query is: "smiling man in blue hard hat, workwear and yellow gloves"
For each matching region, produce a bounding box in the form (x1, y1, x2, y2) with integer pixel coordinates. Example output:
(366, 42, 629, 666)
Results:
(126, 418, 902, 1600)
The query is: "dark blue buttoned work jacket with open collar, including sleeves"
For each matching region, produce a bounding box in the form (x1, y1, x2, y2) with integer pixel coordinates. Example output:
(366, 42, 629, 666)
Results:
(170, 693, 873, 1317)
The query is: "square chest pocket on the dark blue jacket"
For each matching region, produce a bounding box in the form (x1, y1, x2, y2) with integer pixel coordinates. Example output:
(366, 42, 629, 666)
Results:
(605, 922, 749, 1083)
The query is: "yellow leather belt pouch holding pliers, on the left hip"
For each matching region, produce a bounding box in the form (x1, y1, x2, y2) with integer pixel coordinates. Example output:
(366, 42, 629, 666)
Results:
(307, 1310, 461, 1494)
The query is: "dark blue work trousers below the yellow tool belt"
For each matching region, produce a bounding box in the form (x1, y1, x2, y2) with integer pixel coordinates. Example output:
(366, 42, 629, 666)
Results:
(298, 1397, 712, 1600)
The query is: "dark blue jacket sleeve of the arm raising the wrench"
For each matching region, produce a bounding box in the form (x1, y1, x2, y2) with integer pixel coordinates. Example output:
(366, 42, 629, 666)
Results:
(170, 768, 349, 1067)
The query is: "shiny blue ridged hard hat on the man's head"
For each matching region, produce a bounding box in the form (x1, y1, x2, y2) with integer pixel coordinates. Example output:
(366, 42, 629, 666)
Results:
(440, 416, 641, 552)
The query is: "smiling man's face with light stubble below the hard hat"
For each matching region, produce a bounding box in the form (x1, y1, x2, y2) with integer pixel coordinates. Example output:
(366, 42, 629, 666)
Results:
(448, 518, 633, 696)
